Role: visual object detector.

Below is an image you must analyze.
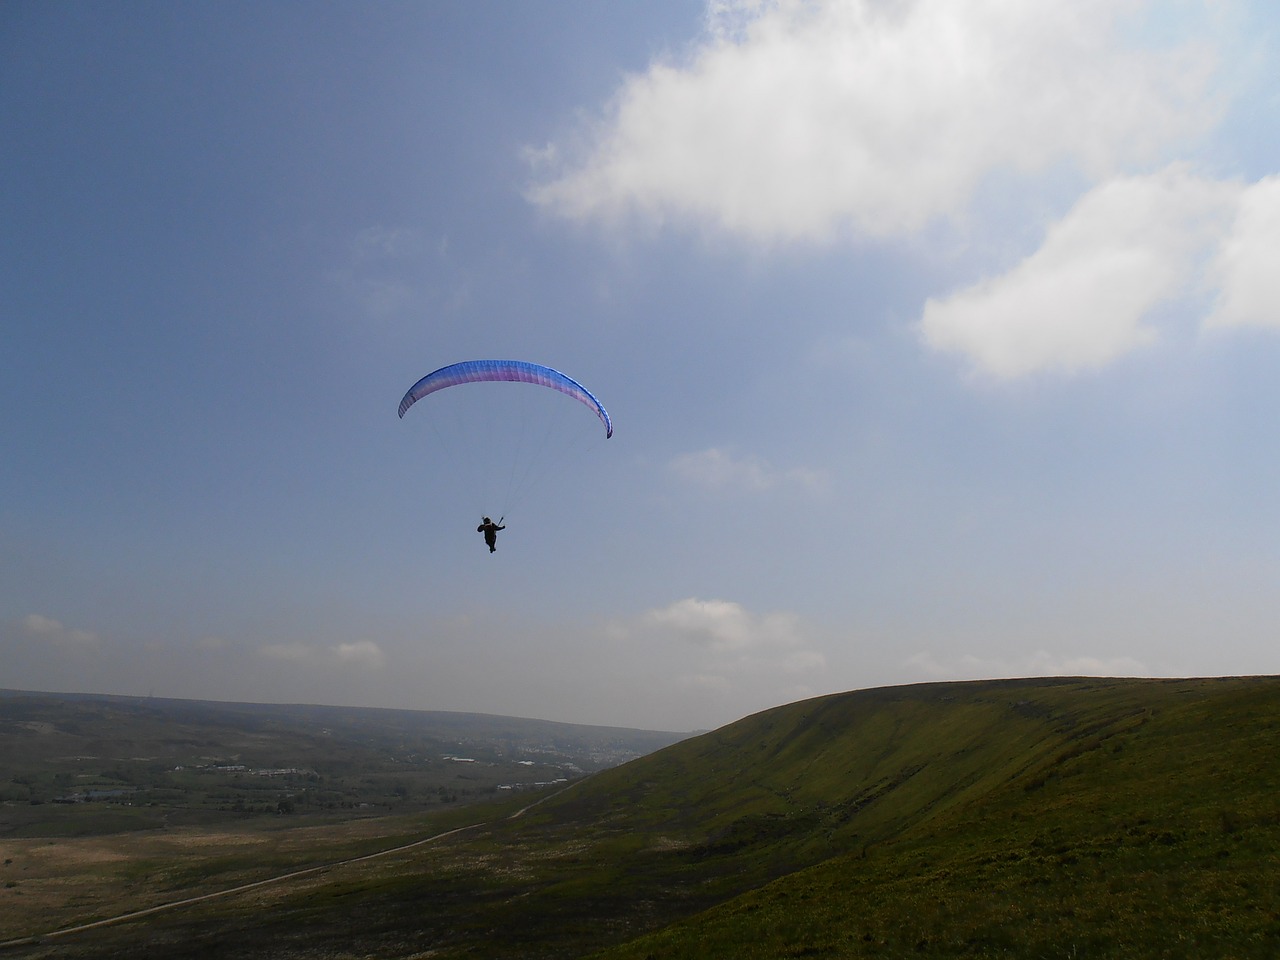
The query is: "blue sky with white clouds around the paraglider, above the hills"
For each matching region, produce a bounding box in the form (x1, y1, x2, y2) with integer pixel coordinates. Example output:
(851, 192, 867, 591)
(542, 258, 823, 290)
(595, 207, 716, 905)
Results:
(0, 0, 1280, 731)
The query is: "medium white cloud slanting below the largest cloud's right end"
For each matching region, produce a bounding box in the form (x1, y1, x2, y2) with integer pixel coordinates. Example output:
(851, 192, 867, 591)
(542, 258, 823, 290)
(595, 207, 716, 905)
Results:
(920, 166, 1240, 378)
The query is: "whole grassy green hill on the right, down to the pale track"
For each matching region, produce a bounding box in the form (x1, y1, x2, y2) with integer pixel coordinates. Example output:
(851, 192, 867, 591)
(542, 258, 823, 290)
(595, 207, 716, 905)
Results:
(5, 678, 1280, 959)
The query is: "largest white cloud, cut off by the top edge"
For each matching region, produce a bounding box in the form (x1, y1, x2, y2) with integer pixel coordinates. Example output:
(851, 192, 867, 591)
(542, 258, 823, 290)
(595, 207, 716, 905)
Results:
(530, 0, 1212, 241)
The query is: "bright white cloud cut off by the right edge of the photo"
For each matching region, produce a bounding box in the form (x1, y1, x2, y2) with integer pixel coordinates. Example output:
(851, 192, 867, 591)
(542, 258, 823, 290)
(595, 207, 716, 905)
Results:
(1206, 174, 1280, 328)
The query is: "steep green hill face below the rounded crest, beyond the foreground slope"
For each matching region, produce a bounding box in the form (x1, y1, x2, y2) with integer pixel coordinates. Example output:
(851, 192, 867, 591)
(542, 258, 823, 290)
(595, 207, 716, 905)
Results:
(535, 680, 1160, 859)
